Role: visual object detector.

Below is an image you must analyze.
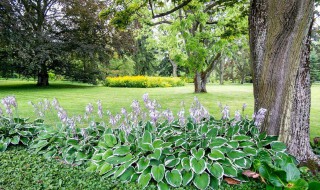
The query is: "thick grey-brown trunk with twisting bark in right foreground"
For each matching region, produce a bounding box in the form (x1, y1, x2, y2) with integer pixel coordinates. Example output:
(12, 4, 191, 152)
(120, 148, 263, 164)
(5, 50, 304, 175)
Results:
(249, 0, 314, 163)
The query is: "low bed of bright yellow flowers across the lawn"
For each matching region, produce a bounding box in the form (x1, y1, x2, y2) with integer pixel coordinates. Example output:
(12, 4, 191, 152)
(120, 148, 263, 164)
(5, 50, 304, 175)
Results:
(105, 76, 184, 88)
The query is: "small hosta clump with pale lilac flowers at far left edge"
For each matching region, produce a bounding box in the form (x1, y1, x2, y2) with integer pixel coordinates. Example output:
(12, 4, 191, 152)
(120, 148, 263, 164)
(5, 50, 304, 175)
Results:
(0, 96, 43, 152)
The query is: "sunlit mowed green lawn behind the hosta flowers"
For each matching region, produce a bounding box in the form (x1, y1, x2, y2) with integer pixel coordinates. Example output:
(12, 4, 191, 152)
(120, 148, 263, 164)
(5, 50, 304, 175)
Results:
(0, 80, 320, 138)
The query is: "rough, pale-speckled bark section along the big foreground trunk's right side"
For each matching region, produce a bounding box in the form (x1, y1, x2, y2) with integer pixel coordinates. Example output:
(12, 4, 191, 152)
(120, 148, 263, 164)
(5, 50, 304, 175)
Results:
(279, 18, 319, 163)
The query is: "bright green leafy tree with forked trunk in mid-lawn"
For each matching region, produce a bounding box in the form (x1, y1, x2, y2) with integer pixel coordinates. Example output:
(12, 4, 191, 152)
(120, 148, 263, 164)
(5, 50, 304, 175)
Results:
(100, 0, 247, 93)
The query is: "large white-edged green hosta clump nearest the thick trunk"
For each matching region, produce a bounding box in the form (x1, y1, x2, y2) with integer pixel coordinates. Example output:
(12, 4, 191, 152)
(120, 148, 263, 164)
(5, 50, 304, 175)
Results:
(87, 97, 292, 189)
